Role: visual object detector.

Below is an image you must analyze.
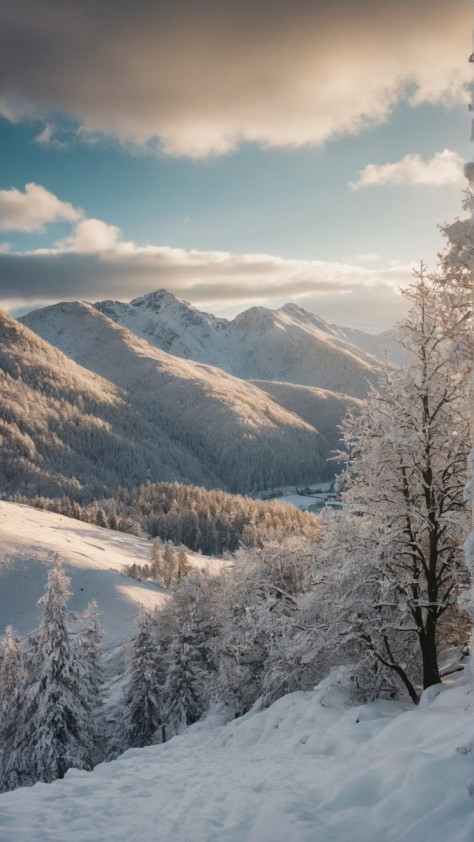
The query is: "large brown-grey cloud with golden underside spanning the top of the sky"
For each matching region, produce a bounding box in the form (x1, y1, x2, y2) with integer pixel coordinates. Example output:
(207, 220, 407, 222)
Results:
(0, 0, 470, 157)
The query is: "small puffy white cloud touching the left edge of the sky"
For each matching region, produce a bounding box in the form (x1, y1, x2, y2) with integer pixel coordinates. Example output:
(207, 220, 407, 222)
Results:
(0, 182, 83, 232)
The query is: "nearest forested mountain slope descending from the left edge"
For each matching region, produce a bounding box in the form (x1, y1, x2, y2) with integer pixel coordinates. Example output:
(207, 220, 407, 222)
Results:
(0, 312, 217, 500)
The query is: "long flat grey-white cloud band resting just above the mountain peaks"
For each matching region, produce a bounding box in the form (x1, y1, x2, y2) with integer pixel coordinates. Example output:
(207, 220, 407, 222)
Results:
(0, 243, 410, 329)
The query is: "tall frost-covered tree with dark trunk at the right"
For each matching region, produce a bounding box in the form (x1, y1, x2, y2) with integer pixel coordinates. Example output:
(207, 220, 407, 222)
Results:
(336, 267, 469, 701)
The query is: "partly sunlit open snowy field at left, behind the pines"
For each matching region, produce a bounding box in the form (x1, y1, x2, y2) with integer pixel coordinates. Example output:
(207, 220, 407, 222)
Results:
(0, 501, 223, 650)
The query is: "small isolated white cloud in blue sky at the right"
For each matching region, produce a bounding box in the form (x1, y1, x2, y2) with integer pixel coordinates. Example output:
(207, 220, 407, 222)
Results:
(349, 149, 464, 190)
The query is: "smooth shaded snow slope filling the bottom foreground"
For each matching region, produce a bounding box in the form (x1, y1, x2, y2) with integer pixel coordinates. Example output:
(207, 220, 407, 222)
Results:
(0, 676, 474, 842)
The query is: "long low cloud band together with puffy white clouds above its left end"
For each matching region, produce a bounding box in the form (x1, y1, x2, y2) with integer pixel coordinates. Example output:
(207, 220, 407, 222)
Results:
(0, 184, 411, 329)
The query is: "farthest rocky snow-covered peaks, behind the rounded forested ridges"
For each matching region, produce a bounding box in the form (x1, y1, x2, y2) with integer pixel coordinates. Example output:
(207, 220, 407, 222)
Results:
(94, 290, 378, 398)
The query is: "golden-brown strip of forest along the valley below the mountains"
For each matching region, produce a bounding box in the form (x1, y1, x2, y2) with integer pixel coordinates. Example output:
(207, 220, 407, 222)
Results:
(10, 482, 319, 555)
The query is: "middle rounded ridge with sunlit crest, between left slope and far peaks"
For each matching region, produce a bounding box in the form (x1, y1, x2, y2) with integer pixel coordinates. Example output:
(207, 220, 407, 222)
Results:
(17, 302, 326, 491)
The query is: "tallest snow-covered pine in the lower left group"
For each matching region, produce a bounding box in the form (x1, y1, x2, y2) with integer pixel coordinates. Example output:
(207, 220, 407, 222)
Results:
(4, 560, 95, 788)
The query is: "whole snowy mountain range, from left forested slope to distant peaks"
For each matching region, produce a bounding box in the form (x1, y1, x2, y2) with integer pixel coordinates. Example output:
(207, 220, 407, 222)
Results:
(0, 290, 398, 500)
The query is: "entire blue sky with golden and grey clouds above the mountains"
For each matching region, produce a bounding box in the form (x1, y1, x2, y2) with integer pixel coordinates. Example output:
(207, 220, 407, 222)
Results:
(0, 0, 472, 332)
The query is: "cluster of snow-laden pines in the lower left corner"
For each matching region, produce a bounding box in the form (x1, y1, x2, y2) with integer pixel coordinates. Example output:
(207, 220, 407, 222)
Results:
(0, 560, 103, 790)
